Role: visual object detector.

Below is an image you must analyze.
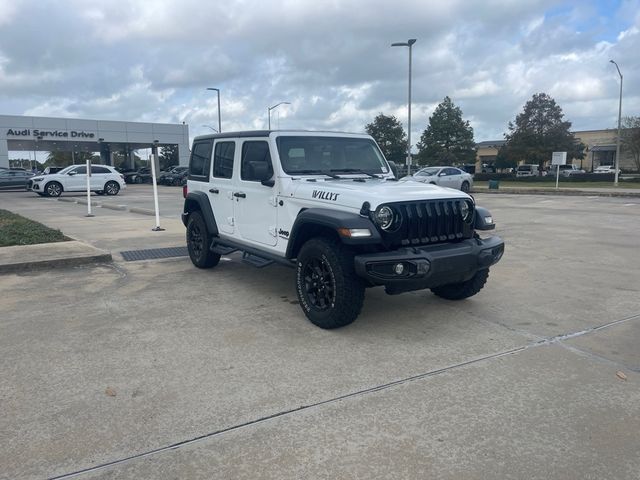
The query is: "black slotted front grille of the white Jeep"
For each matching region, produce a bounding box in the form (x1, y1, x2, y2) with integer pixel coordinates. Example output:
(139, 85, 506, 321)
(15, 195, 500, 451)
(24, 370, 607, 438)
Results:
(388, 199, 473, 246)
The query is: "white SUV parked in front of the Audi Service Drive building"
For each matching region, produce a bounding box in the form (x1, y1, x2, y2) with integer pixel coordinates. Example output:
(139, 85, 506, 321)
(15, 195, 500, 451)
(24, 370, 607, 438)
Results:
(27, 165, 126, 197)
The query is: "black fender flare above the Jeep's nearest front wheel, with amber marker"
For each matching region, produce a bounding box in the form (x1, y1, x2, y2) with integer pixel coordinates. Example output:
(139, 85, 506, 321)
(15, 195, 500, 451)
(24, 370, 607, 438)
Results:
(286, 208, 382, 258)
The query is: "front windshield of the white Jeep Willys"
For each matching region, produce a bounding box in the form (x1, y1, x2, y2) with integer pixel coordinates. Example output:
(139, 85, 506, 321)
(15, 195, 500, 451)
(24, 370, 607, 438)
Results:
(276, 136, 389, 175)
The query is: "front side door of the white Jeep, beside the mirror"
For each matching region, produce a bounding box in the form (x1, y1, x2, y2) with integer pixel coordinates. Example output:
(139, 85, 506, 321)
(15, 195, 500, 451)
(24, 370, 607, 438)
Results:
(233, 139, 277, 245)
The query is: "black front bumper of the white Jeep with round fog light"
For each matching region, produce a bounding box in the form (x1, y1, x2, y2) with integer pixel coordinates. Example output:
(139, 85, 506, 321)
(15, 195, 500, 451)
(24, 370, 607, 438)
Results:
(355, 237, 504, 293)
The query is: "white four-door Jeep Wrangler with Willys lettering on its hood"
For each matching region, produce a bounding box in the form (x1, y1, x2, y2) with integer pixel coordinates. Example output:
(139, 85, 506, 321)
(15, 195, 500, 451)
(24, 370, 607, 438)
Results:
(182, 131, 504, 328)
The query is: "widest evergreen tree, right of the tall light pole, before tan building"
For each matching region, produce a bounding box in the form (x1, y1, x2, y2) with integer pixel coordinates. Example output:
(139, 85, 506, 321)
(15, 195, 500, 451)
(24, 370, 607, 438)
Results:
(500, 93, 585, 169)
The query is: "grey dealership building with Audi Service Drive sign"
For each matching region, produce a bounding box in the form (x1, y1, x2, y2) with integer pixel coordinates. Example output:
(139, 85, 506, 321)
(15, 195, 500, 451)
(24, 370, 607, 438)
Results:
(0, 115, 189, 168)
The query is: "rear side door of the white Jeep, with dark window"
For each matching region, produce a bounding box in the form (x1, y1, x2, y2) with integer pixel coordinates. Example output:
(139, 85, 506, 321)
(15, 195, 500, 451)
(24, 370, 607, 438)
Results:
(207, 139, 237, 234)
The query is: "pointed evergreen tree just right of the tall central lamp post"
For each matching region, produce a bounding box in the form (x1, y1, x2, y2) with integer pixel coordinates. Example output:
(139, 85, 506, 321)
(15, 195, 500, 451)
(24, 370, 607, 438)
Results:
(417, 97, 476, 165)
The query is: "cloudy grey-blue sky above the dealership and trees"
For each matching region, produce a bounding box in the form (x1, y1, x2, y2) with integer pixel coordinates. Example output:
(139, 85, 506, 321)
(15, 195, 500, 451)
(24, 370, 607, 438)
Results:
(0, 0, 640, 143)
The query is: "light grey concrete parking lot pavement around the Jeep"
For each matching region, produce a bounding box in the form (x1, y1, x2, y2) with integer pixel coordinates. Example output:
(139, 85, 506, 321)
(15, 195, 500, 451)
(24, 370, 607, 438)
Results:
(0, 186, 640, 479)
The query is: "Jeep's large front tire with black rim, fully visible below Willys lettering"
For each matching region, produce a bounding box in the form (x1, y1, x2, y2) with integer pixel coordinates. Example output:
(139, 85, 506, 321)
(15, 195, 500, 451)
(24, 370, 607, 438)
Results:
(296, 237, 365, 329)
